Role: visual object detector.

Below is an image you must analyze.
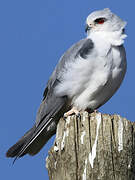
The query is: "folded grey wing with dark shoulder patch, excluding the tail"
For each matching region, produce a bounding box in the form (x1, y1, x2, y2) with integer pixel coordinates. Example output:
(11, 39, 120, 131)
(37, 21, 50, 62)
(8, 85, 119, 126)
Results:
(36, 39, 93, 125)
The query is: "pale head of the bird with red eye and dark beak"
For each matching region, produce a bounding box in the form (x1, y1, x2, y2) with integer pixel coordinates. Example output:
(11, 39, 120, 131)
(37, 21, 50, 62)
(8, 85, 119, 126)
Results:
(85, 8, 126, 34)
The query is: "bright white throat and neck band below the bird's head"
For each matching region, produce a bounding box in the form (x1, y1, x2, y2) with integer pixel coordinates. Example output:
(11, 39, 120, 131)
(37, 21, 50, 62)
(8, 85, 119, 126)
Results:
(87, 30, 127, 46)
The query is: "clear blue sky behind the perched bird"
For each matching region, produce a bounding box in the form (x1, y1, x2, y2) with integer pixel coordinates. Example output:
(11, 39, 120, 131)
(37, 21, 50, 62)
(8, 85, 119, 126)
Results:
(0, 0, 135, 180)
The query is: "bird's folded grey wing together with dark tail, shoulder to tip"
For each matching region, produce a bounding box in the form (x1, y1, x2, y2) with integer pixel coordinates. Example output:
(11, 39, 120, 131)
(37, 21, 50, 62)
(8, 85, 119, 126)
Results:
(7, 39, 93, 160)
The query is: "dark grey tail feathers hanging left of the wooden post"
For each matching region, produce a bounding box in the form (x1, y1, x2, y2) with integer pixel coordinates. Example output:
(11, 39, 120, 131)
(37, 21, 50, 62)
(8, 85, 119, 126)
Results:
(6, 119, 56, 163)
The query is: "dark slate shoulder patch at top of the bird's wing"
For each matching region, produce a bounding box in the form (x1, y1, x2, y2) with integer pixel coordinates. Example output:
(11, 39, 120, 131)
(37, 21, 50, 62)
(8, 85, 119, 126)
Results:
(76, 39, 94, 59)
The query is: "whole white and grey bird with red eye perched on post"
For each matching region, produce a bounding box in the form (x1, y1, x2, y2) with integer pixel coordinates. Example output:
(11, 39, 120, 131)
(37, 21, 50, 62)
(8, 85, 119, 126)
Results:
(6, 8, 127, 161)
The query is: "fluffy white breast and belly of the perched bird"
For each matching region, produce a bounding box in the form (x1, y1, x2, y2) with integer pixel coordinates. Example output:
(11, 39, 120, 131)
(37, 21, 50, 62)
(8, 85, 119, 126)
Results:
(57, 33, 126, 110)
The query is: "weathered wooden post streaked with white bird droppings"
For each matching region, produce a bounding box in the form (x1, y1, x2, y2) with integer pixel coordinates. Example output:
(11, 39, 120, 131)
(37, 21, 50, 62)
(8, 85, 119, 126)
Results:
(46, 112, 135, 180)
